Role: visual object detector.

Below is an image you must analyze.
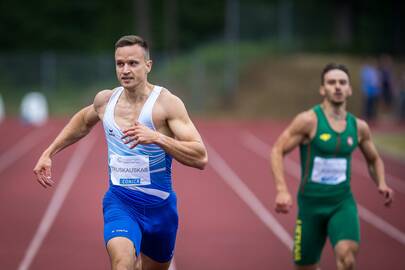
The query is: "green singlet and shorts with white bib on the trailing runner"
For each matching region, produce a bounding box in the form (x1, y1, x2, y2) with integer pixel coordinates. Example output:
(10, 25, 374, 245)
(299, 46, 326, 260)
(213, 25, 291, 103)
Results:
(293, 105, 360, 265)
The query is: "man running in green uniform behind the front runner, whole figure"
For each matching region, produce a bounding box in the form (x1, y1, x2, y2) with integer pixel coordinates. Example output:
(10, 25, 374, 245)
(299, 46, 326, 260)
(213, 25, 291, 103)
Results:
(271, 64, 393, 270)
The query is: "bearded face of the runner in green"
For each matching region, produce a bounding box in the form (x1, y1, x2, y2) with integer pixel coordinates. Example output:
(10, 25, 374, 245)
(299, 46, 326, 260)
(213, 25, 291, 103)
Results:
(320, 69, 352, 105)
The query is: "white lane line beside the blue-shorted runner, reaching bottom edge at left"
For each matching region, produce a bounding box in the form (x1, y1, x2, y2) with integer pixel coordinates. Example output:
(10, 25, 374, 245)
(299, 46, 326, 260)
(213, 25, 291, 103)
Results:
(18, 135, 97, 270)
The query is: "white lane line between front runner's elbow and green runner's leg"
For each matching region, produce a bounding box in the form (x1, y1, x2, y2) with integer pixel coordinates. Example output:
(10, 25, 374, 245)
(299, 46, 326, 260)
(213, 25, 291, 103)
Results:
(206, 143, 293, 250)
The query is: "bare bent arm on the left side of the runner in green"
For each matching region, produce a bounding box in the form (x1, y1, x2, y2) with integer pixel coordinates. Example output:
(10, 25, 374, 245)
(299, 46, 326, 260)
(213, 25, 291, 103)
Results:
(270, 111, 316, 213)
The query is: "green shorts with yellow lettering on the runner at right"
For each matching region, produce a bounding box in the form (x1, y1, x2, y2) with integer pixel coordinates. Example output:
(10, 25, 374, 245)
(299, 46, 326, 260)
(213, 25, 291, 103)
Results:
(293, 194, 360, 265)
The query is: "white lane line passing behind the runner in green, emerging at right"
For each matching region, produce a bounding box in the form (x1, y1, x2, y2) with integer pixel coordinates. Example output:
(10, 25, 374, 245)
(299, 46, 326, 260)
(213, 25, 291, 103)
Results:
(242, 132, 405, 245)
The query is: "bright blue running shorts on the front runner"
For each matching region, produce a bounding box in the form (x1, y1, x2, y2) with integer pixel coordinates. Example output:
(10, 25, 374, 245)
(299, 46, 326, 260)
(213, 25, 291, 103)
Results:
(103, 190, 178, 263)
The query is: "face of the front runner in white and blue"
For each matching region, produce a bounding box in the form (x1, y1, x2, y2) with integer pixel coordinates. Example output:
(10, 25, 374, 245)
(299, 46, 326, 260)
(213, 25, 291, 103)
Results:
(115, 45, 152, 89)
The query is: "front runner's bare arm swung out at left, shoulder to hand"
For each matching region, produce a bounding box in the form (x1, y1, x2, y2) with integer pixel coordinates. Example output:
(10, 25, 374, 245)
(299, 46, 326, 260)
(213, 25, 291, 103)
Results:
(34, 90, 111, 188)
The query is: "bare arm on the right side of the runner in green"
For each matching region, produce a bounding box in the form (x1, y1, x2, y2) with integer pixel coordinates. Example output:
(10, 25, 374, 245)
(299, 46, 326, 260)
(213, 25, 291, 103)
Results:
(357, 120, 393, 206)
